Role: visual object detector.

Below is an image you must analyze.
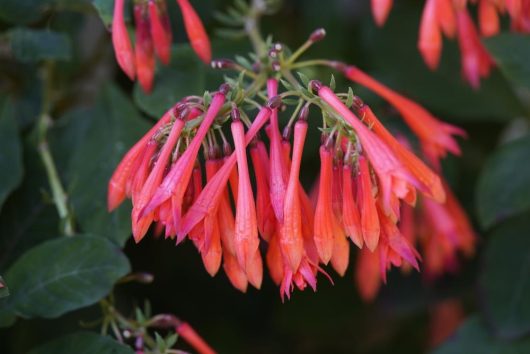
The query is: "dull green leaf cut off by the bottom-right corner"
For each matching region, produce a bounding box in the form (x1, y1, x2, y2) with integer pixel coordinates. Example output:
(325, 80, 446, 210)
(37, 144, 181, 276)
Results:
(432, 316, 530, 354)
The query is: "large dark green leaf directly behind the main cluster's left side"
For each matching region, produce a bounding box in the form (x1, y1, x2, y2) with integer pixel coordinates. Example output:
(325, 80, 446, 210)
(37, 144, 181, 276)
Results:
(68, 86, 149, 245)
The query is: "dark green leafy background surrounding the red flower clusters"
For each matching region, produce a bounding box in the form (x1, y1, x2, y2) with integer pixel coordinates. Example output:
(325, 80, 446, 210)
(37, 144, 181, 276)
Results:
(0, 0, 530, 354)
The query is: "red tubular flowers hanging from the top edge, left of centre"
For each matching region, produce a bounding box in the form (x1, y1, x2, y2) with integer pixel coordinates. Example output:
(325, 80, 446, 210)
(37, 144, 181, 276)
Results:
(112, 0, 211, 92)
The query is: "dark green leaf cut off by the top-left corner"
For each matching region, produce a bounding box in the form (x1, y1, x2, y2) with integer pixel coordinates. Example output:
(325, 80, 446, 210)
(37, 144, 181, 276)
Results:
(0, 0, 54, 24)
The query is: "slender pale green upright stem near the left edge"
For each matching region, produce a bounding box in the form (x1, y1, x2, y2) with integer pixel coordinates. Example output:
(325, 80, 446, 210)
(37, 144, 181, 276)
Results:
(37, 63, 74, 236)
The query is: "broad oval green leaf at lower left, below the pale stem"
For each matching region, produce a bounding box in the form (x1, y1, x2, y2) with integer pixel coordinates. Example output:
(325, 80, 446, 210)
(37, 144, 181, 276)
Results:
(5, 235, 130, 318)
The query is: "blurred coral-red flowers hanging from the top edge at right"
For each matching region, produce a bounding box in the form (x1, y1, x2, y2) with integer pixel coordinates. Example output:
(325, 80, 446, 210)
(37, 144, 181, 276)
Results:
(371, 0, 530, 88)
